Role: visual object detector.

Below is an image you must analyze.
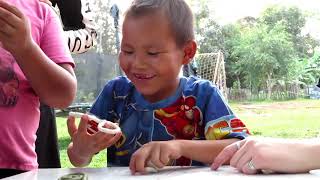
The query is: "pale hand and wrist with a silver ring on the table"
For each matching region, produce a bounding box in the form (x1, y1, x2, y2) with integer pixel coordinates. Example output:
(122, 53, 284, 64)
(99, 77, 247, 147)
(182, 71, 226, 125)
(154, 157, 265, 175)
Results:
(211, 138, 313, 174)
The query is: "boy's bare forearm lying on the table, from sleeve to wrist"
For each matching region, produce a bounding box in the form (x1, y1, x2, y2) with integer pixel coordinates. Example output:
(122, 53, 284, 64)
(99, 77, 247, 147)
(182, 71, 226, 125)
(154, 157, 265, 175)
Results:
(176, 139, 238, 164)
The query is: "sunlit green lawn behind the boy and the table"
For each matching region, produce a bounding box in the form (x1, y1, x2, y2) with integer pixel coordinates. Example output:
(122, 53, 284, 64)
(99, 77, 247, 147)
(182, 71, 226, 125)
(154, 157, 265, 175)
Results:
(57, 100, 320, 167)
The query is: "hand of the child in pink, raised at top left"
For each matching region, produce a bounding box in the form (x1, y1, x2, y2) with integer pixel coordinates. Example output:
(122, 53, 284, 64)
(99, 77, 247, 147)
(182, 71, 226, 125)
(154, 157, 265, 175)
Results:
(0, 0, 34, 54)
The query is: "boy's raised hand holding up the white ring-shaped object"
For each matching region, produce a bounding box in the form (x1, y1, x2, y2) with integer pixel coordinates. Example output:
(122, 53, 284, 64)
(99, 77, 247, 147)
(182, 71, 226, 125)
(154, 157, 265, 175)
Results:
(67, 115, 121, 164)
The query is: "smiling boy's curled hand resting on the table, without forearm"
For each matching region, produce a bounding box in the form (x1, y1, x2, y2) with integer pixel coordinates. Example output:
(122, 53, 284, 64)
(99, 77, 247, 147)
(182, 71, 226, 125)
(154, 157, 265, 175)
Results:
(129, 140, 181, 174)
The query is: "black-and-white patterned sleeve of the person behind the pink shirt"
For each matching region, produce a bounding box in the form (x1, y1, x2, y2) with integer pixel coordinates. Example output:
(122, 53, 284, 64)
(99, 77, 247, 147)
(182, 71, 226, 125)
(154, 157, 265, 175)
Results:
(52, 0, 97, 54)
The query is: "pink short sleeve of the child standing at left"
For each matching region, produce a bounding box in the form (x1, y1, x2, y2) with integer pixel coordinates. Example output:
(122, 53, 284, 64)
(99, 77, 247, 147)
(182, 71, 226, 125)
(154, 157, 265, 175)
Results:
(40, 8, 75, 67)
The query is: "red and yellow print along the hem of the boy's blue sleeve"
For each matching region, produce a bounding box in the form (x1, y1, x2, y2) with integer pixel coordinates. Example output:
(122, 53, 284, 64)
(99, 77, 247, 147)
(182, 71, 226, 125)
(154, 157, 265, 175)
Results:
(205, 115, 250, 140)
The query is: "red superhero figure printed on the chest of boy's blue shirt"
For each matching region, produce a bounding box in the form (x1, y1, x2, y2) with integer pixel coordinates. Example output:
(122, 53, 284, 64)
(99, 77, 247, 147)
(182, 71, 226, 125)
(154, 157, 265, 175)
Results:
(154, 96, 204, 166)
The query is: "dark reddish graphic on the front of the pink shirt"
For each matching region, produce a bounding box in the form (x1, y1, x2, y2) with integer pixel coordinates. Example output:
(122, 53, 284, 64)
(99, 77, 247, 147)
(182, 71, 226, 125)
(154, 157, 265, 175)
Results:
(0, 50, 19, 107)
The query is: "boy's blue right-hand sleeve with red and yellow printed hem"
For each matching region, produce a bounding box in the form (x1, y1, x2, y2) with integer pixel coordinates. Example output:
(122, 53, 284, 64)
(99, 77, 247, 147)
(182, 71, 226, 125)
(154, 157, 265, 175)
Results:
(205, 86, 249, 140)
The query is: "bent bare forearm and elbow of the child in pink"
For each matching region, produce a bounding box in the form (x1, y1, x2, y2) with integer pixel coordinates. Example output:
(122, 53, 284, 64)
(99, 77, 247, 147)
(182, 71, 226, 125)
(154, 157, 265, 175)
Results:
(13, 42, 77, 108)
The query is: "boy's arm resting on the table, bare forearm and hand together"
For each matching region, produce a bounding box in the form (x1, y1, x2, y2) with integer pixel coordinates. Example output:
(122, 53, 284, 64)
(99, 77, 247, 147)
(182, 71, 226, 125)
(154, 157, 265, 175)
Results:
(129, 139, 237, 174)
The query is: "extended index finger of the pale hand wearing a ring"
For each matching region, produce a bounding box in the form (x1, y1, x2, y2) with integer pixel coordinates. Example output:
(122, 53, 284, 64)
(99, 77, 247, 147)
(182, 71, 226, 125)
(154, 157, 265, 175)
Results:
(211, 142, 238, 170)
